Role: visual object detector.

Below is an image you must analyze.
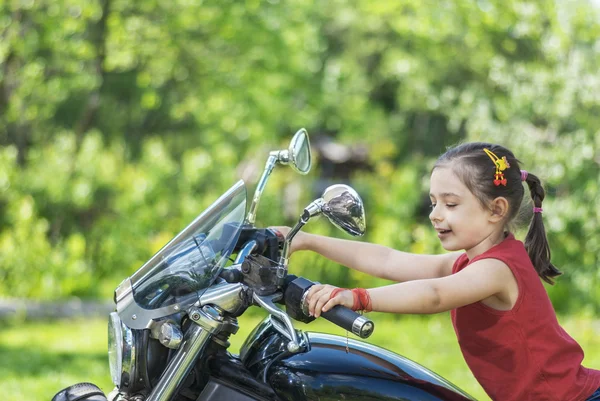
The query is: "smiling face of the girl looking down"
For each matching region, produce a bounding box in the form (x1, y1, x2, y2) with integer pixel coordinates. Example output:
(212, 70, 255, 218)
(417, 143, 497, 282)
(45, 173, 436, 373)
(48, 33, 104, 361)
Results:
(429, 167, 498, 257)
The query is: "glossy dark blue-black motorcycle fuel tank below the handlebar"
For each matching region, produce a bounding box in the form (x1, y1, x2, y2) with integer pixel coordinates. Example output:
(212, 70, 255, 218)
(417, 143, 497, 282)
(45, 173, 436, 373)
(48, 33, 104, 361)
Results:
(241, 319, 474, 401)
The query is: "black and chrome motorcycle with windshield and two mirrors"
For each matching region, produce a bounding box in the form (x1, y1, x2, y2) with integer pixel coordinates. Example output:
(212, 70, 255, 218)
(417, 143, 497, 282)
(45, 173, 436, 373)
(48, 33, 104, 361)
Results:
(53, 129, 474, 401)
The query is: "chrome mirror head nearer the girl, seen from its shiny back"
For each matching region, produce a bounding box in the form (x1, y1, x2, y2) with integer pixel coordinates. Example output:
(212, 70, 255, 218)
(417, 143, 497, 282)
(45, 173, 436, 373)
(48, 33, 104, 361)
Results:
(321, 184, 367, 236)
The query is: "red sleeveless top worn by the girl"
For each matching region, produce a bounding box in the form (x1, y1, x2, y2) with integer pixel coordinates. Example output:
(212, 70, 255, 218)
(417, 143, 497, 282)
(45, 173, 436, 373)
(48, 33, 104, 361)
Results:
(451, 234, 600, 401)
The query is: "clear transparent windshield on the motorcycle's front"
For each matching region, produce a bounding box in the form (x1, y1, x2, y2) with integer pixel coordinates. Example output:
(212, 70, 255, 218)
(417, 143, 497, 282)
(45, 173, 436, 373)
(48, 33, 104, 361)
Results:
(131, 181, 246, 309)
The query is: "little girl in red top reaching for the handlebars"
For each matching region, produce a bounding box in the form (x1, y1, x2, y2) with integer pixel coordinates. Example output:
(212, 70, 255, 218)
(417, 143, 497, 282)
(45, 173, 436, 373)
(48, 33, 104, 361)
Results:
(277, 143, 600, 401)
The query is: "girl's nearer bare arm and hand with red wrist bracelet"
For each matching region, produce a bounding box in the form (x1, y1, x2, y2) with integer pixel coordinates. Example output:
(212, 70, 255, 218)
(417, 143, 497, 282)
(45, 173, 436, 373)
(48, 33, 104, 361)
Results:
(307, 259, 517, 317)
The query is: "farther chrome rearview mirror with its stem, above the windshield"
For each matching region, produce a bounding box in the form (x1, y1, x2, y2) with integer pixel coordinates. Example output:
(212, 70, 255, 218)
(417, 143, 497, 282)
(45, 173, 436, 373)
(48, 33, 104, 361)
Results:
(246, 128, 312, 225)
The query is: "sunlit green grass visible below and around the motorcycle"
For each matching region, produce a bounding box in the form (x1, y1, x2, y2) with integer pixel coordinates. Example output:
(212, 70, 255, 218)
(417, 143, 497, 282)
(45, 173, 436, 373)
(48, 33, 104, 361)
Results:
(0, 313, 600, 401)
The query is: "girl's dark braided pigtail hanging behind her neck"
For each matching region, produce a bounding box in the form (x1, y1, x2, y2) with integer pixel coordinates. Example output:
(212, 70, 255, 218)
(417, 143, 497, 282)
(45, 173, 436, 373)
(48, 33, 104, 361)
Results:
(525, 173, 562, 284)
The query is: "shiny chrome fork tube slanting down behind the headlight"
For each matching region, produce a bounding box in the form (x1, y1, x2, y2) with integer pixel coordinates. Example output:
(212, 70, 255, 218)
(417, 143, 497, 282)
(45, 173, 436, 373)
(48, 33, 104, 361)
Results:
(147, 324, 211, 401)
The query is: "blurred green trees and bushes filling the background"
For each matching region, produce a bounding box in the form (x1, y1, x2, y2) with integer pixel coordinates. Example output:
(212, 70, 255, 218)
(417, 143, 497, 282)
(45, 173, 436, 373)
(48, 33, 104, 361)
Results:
(0, 0, 600, 312)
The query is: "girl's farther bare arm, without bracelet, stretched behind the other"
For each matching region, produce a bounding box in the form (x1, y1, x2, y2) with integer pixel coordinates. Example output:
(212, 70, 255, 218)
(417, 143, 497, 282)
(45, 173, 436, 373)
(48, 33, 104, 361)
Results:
(294, 233, 460, 282)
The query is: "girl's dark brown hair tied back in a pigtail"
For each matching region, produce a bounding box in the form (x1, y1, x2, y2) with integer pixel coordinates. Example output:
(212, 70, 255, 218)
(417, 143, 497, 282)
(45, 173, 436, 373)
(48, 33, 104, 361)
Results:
(433, 142, 562, 284)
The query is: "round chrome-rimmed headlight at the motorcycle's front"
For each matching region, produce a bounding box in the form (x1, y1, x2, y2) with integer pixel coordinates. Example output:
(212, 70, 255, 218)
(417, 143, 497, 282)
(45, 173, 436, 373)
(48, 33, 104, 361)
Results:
(108, 312, 135, 388)
